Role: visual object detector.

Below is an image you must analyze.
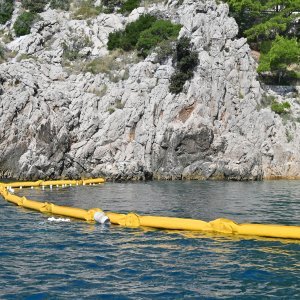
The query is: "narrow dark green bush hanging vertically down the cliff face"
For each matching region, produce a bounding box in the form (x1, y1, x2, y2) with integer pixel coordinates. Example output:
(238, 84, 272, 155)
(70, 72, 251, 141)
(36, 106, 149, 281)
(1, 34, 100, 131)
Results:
(169, 37, 199, 94)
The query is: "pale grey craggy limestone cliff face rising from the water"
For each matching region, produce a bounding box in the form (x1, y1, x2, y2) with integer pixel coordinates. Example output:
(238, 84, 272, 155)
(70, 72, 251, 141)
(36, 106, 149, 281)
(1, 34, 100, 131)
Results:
(0, 0, 300, 180)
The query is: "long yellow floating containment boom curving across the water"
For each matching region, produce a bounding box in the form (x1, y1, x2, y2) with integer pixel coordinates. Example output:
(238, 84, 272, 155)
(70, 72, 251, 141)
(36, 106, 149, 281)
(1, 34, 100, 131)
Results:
(0, 178, 300, 240)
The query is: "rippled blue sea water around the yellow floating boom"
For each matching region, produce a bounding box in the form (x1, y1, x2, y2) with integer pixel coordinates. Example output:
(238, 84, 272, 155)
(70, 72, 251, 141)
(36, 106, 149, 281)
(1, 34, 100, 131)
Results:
(0, 181, 300, 299)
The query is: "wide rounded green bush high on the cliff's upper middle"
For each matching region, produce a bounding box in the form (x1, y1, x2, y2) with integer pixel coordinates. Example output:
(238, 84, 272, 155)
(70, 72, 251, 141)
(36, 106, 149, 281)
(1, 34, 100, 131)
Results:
(107, 15, 181, 57)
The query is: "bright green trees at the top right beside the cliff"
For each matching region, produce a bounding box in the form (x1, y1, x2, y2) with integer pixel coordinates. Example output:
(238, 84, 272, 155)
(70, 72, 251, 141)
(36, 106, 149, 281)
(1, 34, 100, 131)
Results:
(224, 0, 300, 83)
